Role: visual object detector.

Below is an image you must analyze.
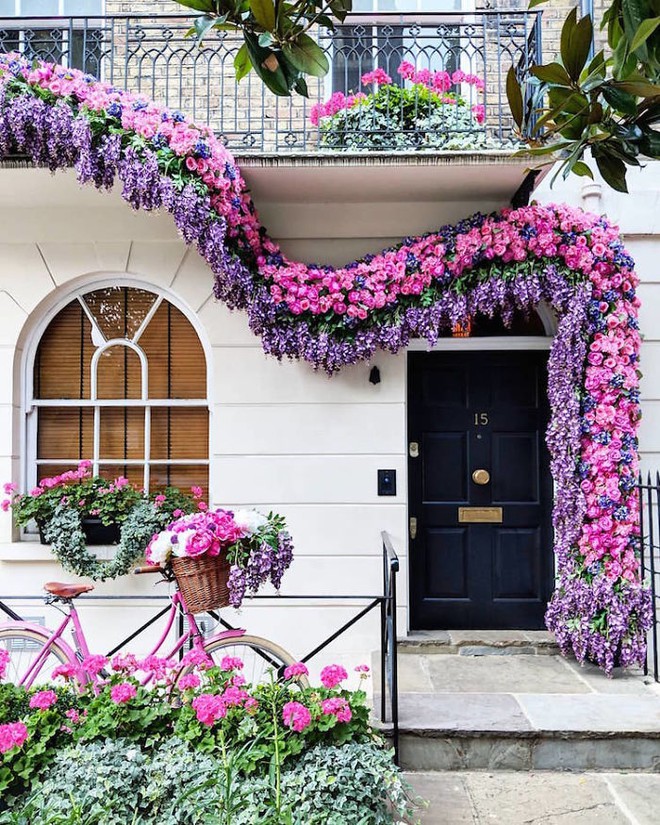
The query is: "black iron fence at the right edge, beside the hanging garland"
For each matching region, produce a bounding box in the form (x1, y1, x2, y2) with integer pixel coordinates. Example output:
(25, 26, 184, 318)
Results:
(638, 473, 660, 682)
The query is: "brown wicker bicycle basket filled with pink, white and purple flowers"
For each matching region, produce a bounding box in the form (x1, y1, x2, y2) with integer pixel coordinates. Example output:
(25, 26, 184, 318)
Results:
(145, 503, 293, 613)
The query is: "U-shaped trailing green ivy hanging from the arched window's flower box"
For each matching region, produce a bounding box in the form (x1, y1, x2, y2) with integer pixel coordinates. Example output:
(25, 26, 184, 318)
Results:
(45, 502, 169, 581)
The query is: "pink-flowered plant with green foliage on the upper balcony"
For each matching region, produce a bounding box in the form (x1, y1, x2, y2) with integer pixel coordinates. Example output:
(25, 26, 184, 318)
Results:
(310, 61, 502, 151)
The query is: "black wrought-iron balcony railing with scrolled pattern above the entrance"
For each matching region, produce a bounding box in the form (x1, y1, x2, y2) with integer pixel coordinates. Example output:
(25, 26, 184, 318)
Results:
(0, 11, 541, 154)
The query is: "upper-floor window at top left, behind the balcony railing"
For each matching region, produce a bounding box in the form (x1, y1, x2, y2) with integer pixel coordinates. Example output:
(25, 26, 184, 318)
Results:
(0, 0, 104, 77)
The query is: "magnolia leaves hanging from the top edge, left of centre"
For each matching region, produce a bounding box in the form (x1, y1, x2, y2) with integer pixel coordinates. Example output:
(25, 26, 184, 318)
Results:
(176, 0, 342, 96)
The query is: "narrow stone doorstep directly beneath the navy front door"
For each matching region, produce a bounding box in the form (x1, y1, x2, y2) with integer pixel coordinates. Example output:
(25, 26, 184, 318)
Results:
(398, 630, 559, 656)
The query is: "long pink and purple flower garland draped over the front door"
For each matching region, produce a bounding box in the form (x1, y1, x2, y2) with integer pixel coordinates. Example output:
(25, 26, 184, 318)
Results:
(0, 54, 651, 672)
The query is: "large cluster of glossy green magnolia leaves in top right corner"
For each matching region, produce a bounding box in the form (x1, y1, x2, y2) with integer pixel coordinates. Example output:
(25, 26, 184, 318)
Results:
(507, 0, 660, 192)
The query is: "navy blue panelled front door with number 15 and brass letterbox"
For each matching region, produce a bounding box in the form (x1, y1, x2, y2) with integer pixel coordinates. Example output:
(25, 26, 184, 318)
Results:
(408, 351, 553, 629)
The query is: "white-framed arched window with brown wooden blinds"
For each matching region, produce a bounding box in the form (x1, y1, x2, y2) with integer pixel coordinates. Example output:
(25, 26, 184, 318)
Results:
(28, 286, 209, 493)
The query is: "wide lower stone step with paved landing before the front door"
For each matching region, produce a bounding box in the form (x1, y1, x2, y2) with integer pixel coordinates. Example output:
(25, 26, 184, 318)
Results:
(374, 654, 660, 772)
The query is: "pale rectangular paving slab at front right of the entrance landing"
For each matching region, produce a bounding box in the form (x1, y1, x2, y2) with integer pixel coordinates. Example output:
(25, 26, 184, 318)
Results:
(516, 693, 660, 738)
